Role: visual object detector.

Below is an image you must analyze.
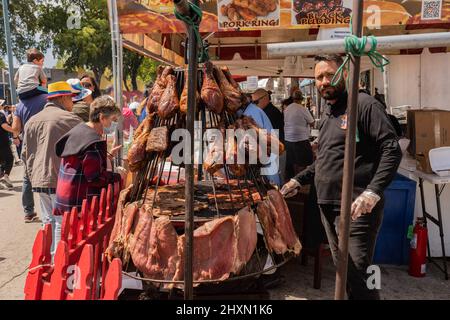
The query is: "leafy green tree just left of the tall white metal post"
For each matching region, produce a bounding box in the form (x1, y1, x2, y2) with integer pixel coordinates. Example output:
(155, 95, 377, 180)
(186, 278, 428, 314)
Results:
(39, 0, 112, 82)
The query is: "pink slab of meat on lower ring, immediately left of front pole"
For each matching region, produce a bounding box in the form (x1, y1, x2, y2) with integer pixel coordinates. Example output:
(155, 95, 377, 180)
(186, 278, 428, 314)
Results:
(130, 207, 179, 280)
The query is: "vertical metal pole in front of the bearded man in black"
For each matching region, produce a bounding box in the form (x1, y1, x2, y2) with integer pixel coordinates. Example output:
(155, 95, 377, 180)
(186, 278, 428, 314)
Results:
(335, 0, 363, 300)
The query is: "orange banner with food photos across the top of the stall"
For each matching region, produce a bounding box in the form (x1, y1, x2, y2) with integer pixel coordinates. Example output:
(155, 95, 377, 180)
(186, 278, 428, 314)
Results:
(117, 0, 450, 34)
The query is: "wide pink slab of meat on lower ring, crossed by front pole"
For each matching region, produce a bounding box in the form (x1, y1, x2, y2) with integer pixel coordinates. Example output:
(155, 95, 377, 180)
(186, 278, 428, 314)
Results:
(175, 217, 237, 281)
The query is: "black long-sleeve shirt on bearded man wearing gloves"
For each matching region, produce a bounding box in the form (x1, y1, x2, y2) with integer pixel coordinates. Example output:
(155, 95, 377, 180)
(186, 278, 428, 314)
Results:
(295, 93, 402, 205)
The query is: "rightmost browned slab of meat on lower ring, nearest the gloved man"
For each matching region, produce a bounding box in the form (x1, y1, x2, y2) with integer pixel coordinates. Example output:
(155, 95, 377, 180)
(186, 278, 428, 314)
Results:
(267, 190, 302, 255)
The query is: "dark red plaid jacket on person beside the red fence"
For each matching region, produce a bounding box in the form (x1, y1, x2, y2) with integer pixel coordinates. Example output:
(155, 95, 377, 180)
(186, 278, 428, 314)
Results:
(55, 124, 120, 215)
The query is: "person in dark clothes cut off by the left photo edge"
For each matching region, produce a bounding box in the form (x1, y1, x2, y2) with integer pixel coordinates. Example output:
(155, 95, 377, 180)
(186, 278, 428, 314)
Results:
(0, 104, 14, 190)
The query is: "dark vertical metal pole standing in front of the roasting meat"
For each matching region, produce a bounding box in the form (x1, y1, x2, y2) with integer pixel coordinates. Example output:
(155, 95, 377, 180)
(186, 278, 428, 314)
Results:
(174, 0, 198, 300)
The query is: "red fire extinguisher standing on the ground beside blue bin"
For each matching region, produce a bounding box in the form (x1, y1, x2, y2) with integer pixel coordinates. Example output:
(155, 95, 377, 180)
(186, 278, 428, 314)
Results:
(409, 218, 428, 278)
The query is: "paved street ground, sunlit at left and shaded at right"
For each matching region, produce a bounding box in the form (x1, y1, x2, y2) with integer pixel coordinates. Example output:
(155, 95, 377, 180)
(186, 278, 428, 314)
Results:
(0, 167, 450, 300)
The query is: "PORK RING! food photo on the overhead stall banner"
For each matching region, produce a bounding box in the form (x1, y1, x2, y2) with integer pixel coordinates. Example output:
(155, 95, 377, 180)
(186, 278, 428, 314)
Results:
(217, 0, 280, 30)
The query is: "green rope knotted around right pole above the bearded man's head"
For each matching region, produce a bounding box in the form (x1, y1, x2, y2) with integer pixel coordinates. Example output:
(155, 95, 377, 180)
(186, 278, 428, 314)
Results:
(331, 35, 390, 86)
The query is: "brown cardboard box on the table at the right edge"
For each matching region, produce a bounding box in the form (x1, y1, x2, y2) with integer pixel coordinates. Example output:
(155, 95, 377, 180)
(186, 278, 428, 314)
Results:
(407, 109, 450, 173)
